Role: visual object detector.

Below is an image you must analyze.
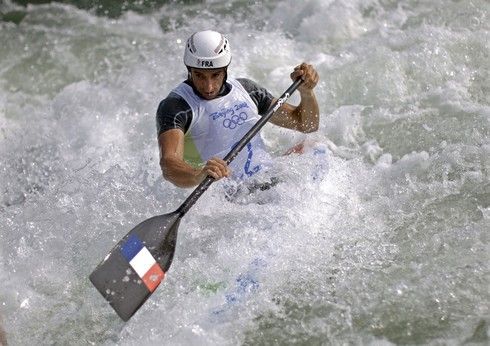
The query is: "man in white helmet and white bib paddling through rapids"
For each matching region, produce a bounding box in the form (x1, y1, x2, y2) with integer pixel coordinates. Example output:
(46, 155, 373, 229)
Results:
(157, 30, 320, 187)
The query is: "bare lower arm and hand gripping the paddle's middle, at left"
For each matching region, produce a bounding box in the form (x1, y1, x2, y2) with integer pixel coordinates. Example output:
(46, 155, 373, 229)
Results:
(158, 129, 231, 187)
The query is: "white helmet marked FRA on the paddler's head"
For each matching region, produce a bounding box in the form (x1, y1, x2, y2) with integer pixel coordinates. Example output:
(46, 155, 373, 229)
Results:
(184, 30, 231, 69)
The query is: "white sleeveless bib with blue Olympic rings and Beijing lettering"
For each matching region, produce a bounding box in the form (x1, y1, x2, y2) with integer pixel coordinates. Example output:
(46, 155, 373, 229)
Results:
(173, 78, 270, 179)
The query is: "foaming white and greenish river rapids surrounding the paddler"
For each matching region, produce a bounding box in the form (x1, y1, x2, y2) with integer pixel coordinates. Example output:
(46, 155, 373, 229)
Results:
(0, 0, 490, 345)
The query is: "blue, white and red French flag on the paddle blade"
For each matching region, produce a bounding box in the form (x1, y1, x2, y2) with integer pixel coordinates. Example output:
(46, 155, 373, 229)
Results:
(121, 234, 165, 292)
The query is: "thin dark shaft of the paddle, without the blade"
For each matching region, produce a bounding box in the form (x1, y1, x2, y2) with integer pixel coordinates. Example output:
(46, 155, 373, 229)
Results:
(177, 78, 303, 217)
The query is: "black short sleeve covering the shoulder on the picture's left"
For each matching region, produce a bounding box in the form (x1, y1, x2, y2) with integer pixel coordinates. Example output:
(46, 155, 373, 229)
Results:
(156, 92, 192, 135)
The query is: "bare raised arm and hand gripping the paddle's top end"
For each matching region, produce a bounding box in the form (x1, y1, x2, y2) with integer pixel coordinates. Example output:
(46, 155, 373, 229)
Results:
(271, 63, 320, 133)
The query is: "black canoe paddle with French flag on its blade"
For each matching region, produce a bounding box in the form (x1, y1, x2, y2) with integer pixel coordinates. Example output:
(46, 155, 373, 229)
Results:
(90, 79, 302, 321)
